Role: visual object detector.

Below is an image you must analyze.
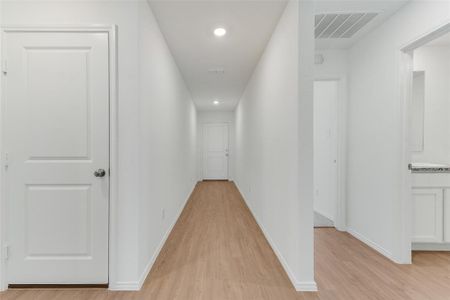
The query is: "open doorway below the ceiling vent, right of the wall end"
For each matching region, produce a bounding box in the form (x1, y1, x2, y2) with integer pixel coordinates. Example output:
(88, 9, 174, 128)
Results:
(313, 78, 346, 231)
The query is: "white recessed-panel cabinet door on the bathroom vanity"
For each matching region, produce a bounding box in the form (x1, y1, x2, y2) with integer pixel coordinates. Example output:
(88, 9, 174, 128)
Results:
(412, 188, 444, 243)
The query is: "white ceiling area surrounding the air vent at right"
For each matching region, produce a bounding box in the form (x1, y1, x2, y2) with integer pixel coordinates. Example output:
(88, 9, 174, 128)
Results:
(315, 0, 409, 50)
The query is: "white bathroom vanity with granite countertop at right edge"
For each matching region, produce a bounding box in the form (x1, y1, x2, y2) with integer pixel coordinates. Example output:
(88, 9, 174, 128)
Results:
(410, 163, 450, 250)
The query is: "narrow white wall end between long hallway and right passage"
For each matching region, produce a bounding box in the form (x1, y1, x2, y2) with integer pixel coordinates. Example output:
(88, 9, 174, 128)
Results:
(296, 0, 317, 291)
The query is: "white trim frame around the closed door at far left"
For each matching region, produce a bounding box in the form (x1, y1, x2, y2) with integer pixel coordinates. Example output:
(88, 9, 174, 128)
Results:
(0, 25, 119, 291)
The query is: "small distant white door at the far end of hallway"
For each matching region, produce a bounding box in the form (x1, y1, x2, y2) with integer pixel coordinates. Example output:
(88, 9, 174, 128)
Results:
(203, 124, 229, 180)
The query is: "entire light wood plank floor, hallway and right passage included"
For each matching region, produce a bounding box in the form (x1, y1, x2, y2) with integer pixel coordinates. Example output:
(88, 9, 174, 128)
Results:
(0, 181, 450, 300)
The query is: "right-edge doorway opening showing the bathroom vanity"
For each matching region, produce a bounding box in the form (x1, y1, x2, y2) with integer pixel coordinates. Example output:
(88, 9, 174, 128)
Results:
(401, 23, 450, 262)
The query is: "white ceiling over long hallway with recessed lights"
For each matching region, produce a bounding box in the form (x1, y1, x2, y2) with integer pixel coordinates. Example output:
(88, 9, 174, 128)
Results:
(150, 1, 286, 110)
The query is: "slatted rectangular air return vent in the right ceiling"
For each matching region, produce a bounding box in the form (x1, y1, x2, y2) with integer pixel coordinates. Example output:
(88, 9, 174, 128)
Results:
(315, 13, 378, 39)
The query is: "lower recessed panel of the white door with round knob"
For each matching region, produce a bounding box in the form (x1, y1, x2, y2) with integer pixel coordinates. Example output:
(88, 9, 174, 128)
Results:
(25, 185, 92, 259)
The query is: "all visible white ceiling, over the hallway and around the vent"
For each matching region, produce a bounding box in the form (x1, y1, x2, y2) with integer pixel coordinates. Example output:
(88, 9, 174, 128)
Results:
(149, 0, 409, 110)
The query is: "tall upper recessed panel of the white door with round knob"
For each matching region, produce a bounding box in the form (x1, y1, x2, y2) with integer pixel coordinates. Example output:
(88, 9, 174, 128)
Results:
(24, 47, 91, 159)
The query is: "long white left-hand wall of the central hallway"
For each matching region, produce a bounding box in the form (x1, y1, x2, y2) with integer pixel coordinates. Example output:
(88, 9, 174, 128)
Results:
(138, 2, 197, 290)
